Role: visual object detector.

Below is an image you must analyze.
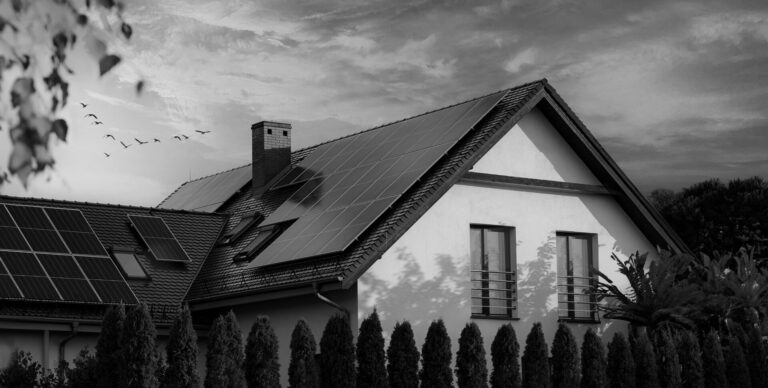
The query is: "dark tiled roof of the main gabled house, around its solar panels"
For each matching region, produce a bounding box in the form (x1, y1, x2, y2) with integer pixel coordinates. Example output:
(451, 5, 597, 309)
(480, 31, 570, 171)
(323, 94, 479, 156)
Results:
(183, 80, 686, 303)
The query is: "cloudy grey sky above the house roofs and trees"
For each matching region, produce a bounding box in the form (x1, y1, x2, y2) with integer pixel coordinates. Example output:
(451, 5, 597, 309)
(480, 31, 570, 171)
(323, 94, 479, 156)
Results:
(0, 0, 768, 206)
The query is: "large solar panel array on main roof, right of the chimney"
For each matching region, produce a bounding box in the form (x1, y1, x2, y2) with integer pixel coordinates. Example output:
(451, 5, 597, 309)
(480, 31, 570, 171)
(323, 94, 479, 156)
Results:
(250, 91, 506, 267)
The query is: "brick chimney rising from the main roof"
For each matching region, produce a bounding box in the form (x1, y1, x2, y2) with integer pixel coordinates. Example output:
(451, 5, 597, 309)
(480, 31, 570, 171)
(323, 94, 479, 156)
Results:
(251, 121, 291, 192)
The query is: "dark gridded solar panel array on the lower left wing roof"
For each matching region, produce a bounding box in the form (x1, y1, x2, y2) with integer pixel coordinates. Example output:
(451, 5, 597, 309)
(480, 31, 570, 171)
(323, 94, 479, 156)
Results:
(0, 204, 138, 304)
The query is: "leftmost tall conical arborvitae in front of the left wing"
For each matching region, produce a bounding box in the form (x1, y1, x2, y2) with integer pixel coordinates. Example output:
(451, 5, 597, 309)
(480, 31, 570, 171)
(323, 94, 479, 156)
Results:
(95, 304, 125, 388)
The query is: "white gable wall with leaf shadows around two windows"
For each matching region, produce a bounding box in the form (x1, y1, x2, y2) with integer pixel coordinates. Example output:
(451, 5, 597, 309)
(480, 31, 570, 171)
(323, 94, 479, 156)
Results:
(358, 106, 654, 365)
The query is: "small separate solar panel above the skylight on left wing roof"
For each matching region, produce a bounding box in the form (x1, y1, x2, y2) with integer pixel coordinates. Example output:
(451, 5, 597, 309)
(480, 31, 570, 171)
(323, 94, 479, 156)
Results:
(128, 214, 190, 262)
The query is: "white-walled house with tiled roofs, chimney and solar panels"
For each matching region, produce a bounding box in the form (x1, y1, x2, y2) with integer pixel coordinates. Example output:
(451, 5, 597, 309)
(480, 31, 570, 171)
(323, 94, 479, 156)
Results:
(0, 80, 686, 379)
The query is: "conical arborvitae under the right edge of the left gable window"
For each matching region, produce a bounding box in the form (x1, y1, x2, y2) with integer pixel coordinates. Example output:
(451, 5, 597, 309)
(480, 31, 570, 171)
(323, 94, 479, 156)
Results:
(491, 323, 522, 388)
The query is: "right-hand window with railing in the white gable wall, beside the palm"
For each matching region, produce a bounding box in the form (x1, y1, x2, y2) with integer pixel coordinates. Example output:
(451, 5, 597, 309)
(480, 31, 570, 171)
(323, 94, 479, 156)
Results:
(557, 233, 599, 321)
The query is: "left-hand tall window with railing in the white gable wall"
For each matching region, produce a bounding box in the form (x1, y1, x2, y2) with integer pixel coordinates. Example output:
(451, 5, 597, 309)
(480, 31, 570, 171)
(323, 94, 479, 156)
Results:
(470, 225, 517, 319)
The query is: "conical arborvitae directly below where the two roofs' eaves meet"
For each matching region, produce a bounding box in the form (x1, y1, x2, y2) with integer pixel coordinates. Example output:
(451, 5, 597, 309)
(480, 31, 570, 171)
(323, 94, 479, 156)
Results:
(164, 305, 200, 388)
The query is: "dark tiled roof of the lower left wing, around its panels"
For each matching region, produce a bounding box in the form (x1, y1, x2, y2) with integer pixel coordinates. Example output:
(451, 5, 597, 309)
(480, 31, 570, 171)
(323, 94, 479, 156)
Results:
(0, 196, 227, 323)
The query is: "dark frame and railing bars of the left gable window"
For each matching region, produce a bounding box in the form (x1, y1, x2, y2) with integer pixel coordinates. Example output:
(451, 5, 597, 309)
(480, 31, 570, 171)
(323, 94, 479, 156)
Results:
(469, 224, 519, 321)
